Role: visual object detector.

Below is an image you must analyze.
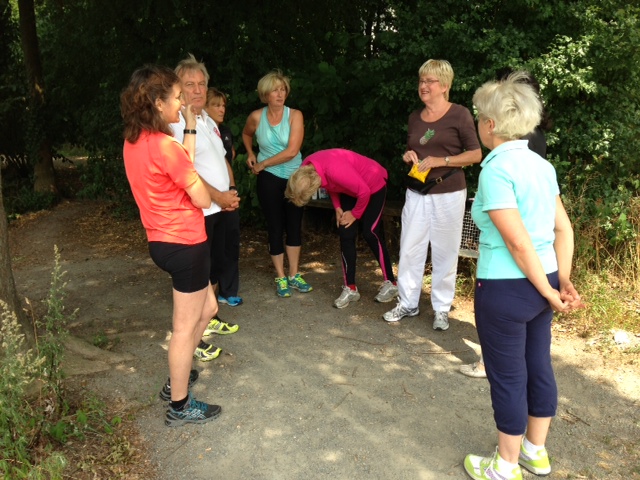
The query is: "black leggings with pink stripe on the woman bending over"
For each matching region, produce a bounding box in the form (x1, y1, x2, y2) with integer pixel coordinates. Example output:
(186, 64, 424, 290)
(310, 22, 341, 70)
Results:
(338, 186, 395, 285)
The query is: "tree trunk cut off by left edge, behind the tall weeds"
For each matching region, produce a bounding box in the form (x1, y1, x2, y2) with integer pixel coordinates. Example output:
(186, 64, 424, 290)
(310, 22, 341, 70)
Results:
(0, 165, 35, 348)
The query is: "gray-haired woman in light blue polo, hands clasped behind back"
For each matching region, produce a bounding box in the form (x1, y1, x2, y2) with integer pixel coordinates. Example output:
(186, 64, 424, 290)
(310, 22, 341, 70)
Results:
(464, 72, 582, 480)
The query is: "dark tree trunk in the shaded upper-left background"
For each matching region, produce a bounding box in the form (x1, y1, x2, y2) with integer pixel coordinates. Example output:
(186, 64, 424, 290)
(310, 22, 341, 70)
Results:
(18, 0, 58, 194)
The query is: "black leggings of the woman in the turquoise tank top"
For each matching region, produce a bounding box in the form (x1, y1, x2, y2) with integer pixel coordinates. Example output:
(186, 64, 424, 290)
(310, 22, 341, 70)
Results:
(258, 170, 304, 256)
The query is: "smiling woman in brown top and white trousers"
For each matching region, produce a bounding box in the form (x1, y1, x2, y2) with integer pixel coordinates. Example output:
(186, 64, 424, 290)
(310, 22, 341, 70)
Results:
(383, 60, 482, 330)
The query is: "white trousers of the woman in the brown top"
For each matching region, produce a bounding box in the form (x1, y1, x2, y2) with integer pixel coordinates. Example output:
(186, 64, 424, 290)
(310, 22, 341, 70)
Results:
(398, 189, 467, 312)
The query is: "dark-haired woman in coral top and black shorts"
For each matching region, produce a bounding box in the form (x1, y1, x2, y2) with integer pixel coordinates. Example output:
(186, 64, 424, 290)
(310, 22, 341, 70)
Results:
(120, 65, 221, 427)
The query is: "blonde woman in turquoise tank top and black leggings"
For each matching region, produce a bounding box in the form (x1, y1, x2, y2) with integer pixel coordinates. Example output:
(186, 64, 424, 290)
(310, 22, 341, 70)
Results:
(242, 71, 312, 297)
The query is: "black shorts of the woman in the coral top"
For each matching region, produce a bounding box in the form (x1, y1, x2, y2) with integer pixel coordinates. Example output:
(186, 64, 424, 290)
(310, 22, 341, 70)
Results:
(149, 242, 210, 293)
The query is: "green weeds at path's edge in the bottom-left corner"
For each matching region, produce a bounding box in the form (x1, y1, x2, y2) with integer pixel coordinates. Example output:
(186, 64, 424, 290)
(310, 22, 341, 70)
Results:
(0, 247, 121, 479)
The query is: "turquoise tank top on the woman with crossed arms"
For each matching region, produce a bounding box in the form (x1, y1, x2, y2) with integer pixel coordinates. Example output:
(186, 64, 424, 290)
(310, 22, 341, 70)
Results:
(256, 107, 302, 179)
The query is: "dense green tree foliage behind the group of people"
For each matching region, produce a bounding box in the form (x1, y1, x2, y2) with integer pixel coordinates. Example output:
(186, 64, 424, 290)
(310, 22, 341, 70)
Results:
(0, 0, 640, 265)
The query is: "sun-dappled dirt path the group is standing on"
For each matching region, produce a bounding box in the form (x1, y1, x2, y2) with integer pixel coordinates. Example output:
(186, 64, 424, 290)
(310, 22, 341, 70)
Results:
(10, 202, 640, 480)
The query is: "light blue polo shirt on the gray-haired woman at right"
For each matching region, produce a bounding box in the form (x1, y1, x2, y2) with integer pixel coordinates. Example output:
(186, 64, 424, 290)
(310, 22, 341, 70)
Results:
(471, 140, 560, 279)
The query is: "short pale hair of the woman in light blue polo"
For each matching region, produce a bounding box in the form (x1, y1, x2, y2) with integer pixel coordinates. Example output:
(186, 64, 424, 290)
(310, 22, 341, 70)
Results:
(473, 71, 542, 140)
